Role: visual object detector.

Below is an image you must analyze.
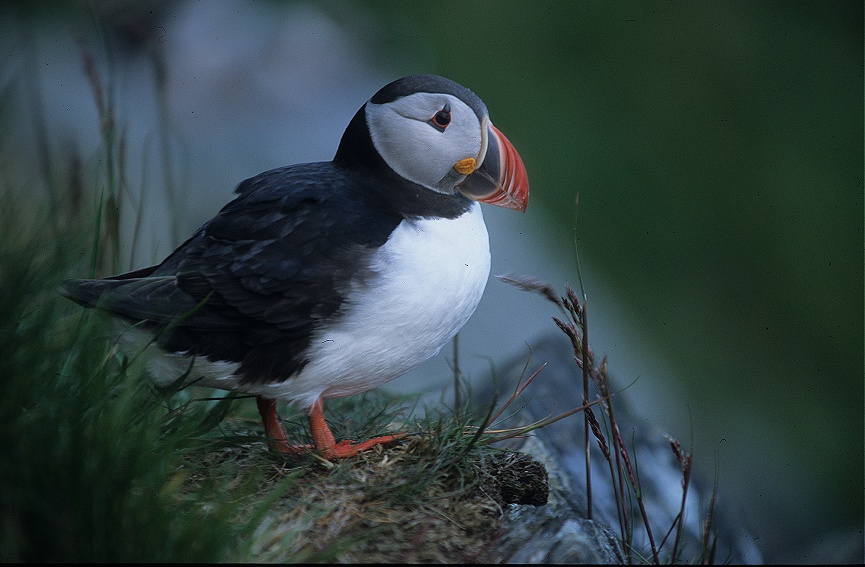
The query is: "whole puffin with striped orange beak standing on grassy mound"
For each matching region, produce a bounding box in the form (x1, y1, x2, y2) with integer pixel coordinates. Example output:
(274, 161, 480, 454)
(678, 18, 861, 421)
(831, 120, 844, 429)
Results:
(60, 74, 529, 460)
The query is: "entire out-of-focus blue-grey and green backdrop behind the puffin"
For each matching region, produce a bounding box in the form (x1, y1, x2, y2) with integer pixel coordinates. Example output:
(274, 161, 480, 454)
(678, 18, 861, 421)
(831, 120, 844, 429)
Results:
(0, 0, 863, 561)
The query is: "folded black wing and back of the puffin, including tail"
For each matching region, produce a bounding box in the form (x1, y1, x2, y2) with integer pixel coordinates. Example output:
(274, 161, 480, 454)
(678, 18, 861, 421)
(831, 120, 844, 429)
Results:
(64, 163, 402, 382)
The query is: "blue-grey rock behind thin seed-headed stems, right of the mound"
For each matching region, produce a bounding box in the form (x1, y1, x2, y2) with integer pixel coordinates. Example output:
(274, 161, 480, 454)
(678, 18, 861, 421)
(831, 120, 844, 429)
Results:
(477, 333, 762, 563)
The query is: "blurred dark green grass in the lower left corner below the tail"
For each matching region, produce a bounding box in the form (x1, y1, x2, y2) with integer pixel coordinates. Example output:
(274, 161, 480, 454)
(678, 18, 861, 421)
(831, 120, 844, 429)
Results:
(0, 194, 274, 561)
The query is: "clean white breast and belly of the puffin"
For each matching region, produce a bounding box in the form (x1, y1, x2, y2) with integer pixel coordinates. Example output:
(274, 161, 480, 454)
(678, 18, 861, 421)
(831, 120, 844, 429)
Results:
(265, 203, 490, 405)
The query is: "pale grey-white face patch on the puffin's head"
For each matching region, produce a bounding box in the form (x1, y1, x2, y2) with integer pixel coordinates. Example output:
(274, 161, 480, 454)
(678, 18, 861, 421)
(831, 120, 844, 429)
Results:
(366, 93, 486, 194)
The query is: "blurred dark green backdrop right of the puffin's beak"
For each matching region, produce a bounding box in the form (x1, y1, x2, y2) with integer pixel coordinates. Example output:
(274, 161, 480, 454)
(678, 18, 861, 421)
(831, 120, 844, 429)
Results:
(3, 0, 863, 558)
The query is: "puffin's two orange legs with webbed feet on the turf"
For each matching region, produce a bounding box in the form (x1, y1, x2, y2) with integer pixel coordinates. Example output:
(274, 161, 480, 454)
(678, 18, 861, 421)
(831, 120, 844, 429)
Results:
(256, 396, 404, 459)
